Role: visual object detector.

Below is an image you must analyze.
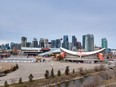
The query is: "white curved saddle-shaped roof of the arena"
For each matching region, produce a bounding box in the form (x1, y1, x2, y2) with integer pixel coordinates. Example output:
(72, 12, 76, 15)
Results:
(60, 47, 105, 56)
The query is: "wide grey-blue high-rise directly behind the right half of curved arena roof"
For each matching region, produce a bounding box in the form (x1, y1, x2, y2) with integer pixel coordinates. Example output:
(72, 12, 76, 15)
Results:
(83, 34, 94, 51)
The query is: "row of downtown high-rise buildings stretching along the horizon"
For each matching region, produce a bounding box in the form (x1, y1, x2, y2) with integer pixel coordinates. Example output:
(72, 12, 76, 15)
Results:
(0, 34, 109, 51)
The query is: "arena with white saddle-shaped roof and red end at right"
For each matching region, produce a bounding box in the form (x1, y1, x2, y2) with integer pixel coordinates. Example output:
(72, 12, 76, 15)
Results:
(60, 47, 105, 63)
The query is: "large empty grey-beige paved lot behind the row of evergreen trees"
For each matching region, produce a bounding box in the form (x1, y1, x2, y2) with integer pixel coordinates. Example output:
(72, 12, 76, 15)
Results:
(0, 61, 99, 85)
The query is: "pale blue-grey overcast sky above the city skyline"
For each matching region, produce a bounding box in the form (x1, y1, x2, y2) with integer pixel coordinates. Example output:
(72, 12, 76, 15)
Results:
(0, 0, 116, 48)
